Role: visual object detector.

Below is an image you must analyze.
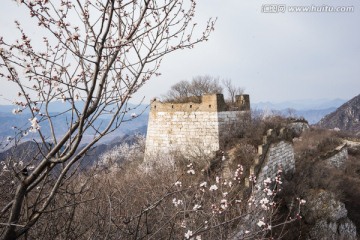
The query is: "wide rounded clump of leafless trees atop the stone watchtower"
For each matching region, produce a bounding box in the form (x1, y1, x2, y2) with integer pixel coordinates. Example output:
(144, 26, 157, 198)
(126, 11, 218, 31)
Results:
(164, 75, 223, 102)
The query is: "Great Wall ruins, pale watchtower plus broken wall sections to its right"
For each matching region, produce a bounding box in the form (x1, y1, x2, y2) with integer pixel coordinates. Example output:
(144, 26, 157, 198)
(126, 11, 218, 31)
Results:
(145, 94, 347, 182)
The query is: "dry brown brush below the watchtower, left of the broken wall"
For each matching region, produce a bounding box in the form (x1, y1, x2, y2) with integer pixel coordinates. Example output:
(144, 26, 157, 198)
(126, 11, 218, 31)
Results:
(1, 115, 306, 239)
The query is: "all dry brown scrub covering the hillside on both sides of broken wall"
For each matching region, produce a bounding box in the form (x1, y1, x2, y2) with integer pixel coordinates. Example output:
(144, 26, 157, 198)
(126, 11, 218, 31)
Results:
(1, 113, 360, 239)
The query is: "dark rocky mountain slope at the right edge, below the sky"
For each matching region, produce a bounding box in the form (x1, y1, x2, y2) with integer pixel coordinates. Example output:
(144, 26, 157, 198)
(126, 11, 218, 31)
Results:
(318, 94, 360, 135)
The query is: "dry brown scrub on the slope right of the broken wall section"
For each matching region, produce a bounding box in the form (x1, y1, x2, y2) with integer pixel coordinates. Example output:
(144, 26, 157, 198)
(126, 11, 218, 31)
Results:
(272, 128, 360, 239)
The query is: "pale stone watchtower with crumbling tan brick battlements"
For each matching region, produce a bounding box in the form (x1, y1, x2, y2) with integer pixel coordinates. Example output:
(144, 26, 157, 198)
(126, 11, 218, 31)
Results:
(145, 94, 250, 160)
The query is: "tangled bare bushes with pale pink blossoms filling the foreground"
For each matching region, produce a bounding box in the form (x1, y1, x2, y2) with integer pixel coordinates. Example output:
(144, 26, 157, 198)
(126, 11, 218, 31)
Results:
(1, 150, 300, 239)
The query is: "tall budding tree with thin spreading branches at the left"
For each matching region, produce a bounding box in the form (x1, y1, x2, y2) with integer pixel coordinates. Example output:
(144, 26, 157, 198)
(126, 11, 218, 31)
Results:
(0, 0, 214, 239)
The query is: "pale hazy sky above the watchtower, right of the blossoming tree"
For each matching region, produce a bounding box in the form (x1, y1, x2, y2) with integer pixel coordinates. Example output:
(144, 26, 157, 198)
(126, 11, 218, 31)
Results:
(0, 0, 360, 103)
